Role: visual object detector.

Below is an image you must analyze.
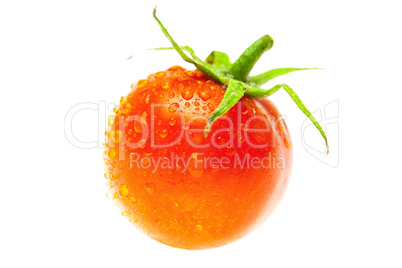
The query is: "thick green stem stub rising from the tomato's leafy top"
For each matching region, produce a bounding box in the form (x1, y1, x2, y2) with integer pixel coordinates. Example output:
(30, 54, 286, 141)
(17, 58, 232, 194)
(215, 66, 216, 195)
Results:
(228, 35, 274, 82)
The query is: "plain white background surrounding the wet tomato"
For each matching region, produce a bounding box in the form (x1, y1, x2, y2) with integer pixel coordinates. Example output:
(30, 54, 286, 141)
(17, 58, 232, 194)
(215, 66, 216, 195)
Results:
(0, 0, 402, 268)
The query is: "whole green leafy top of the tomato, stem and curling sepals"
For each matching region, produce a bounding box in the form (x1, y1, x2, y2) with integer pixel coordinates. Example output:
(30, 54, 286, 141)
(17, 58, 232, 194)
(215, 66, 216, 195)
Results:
(153, 7, 328, 154)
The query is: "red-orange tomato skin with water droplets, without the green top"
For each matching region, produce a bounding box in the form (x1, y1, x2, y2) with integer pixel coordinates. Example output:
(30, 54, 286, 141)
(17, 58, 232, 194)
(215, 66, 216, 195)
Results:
(105, 66, 292, 249)
